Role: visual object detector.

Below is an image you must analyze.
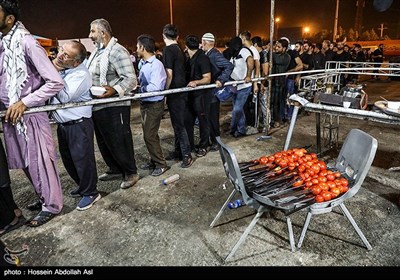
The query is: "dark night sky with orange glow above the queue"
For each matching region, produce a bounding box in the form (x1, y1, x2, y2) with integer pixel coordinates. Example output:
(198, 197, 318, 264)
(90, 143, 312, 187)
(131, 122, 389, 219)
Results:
(20, 0, 400, 46)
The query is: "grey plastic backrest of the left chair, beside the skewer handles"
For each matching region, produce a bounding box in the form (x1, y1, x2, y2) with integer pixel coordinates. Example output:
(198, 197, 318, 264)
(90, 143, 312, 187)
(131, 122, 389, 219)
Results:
(216, 137, 260, 208)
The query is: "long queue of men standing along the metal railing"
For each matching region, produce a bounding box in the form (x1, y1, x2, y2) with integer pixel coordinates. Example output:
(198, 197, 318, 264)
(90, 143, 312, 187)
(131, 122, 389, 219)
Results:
(0, 0, 394, 235)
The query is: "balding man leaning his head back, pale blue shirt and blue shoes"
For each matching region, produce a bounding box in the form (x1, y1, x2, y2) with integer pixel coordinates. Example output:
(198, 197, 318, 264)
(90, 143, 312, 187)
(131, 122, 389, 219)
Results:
(51, 40, 101, 210)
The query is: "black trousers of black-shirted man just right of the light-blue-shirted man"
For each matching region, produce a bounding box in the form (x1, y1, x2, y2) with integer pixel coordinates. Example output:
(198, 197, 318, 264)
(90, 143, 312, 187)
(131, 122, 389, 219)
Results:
(167, 92, 191, 156)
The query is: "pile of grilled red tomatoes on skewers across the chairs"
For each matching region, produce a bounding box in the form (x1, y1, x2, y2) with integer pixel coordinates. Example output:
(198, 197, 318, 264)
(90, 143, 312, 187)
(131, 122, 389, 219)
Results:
(254, 148, 349, 202)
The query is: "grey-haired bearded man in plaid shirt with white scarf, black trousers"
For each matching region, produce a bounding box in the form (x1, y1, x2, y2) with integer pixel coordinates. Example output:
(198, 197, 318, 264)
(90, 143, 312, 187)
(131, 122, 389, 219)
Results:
(87, 19, 139, 189)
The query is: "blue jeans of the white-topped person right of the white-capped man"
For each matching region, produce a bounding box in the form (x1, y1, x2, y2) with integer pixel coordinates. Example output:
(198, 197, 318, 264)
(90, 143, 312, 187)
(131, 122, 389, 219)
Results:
(231, 87, 251, 135)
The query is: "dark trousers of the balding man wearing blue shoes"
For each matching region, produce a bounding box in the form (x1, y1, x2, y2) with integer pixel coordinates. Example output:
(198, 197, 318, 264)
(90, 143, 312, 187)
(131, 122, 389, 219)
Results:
(57, 119, 98, 196)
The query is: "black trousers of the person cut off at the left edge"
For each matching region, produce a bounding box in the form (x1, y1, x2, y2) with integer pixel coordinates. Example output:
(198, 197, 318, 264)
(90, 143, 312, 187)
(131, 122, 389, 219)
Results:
(0, 140, 18, 228)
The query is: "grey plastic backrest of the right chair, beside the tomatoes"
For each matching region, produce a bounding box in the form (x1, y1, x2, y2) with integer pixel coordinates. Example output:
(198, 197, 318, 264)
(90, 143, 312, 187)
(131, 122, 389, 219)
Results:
(335, 129, 378, 199)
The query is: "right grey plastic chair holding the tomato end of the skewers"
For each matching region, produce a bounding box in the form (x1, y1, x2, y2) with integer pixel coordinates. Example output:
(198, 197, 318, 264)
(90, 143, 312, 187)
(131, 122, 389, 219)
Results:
(297, 129, 378, 250)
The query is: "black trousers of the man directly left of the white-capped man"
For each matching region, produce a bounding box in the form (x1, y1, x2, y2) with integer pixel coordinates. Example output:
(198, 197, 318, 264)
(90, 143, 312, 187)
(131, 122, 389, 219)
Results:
(185, 90, 212, 150)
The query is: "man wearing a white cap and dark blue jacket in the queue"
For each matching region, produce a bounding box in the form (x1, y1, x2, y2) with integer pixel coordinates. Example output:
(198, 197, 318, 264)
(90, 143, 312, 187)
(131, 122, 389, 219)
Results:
(201, 33, 233, 151)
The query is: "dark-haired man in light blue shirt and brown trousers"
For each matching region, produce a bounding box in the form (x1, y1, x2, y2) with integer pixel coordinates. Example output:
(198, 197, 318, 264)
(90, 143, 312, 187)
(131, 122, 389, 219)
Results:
(136, 34, 170, 176)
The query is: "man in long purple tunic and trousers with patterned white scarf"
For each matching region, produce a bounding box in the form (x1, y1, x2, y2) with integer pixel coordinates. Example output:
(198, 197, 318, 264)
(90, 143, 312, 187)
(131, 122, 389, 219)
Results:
(0, 0, 64, 227)
